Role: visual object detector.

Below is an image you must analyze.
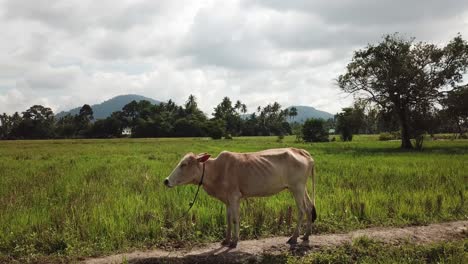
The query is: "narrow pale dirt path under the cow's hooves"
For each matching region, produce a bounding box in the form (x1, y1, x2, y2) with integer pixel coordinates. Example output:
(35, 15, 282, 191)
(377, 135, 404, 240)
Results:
(84, 221, 468, 264)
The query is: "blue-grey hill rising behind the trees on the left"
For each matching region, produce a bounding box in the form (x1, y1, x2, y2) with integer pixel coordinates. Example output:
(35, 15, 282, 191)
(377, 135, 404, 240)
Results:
(55, 94, 161, 119)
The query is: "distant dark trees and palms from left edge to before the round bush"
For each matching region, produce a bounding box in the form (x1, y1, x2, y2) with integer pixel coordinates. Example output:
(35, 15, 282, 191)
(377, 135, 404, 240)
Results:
(0, 95, 297, 139)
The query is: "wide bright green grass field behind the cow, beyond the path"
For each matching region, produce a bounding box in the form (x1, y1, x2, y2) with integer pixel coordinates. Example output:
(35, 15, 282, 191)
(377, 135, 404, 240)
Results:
(0, 136, 468, 260)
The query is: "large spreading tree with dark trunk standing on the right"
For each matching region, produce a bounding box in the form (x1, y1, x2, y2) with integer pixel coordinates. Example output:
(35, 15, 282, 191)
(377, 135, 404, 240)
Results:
(338, 34, 468, 149)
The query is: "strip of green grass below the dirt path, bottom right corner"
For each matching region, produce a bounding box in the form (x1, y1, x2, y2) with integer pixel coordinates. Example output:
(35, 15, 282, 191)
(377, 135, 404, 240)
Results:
(258, 237, 468, 264)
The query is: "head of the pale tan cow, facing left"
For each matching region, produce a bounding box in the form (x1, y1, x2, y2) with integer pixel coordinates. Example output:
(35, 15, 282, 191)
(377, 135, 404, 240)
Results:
(164, 153, 211, 187)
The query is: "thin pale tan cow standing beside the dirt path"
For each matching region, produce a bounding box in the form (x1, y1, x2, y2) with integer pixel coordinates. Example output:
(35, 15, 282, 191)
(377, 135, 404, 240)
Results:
(164, 148, 317, 248)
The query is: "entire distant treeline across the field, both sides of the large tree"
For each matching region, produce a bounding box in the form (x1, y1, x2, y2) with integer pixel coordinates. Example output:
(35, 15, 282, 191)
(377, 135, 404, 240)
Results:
(0, 89, 467, 141)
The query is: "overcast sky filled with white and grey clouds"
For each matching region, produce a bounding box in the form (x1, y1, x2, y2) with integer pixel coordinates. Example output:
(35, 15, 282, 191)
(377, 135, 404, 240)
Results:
(0, 0, 468, 113)
